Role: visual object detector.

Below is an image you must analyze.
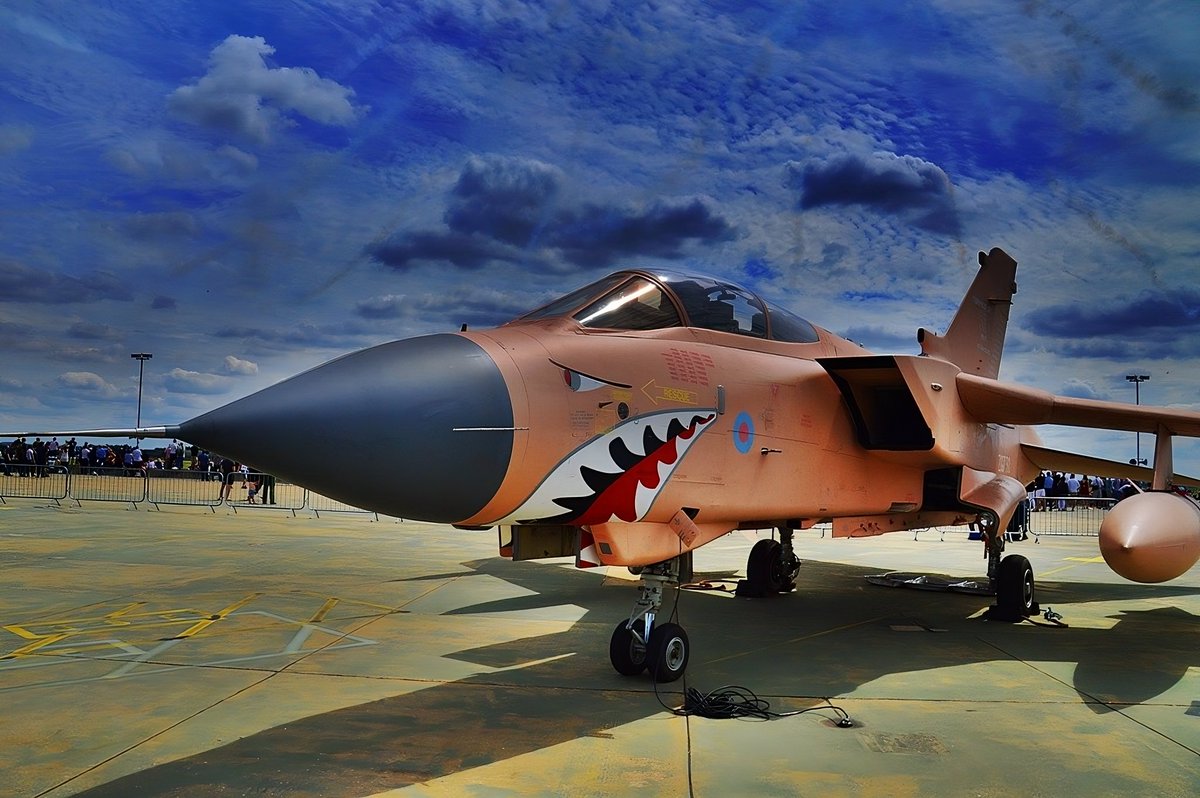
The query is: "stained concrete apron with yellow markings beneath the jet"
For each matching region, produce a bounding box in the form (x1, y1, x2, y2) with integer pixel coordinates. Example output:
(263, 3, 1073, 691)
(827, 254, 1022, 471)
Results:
(0, 502, 1200, 797)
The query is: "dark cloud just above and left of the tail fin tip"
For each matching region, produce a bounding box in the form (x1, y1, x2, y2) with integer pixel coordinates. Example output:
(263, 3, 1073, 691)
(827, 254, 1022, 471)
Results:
(786, 154, 962, 235)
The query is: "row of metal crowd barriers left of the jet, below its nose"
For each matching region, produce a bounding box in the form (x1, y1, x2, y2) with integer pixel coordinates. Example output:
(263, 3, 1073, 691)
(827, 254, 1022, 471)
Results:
(0, 463, 378, 517)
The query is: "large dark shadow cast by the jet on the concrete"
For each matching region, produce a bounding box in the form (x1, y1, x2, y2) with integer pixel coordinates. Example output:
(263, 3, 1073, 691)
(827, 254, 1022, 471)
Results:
(80, 559, 1200, 797)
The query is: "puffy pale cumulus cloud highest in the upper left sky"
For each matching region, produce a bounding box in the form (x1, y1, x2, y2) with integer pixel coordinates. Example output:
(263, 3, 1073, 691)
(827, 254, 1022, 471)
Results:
(167, 35, 364, 143)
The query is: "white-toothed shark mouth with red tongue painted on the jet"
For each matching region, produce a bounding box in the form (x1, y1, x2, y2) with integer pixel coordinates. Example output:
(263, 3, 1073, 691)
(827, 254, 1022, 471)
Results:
(514, 409, 716, 526)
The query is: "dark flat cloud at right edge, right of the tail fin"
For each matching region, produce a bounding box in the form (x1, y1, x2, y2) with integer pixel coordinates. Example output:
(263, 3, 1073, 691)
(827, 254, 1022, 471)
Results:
(1025, 288, 1200, 338)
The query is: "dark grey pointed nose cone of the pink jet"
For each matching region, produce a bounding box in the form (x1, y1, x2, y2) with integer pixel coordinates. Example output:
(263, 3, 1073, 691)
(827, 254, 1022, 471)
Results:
(179, 335, 512, 523)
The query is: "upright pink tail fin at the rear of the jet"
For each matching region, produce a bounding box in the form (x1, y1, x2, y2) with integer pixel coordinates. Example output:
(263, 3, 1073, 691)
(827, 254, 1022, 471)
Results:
(917, 247, 1016, 379)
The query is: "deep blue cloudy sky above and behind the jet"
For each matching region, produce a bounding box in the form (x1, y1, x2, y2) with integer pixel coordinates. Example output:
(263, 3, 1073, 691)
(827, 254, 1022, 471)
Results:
(0, 0, 1200, 474)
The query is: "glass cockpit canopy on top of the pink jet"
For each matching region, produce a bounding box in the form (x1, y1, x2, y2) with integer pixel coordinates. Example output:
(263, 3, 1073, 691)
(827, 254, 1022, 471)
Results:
(521, 271, 818, 343)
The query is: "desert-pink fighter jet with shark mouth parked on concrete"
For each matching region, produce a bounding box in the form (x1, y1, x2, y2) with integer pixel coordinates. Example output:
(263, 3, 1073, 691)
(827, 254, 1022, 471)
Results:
(4, 248, 1200, 682)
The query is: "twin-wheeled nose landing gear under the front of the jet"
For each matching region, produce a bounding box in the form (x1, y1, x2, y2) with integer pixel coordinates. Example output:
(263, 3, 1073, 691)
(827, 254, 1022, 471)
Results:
(608, 558, 691, 682)
